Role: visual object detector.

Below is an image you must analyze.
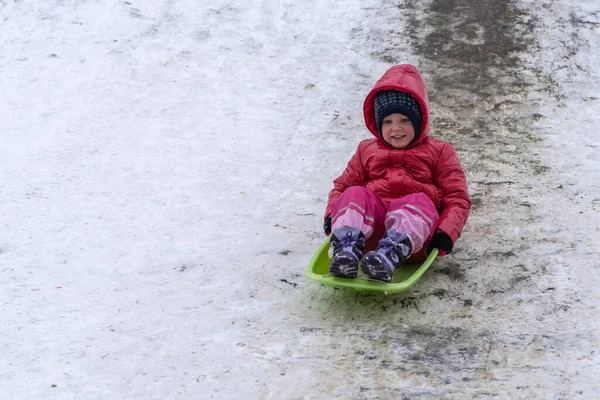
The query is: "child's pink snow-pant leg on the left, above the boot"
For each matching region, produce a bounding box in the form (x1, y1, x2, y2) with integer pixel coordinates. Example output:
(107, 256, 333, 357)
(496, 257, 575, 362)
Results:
(331, 186, 386, 239)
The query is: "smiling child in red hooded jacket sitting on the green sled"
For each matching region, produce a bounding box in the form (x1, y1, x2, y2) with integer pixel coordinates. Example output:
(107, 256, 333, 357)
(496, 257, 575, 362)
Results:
(324, 64, 471, 282)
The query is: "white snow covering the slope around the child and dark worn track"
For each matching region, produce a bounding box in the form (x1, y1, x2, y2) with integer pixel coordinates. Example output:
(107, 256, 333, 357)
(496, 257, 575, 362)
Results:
(0, 0, 600, 399)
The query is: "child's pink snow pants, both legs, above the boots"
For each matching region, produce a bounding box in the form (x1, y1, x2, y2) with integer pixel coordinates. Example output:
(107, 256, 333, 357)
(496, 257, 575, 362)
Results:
(331, 186, 440, 254)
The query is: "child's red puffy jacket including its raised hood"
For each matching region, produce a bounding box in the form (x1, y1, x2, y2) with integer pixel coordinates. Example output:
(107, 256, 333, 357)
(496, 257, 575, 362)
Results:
(325, 64, 471, 243)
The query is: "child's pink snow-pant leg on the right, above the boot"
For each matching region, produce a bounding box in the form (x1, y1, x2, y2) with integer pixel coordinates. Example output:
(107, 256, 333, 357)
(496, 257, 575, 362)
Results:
(385, 193, 440, 254)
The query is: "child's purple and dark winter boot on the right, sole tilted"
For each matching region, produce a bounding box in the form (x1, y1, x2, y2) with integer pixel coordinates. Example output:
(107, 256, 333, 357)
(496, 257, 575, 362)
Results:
(361, 229, 412, 282)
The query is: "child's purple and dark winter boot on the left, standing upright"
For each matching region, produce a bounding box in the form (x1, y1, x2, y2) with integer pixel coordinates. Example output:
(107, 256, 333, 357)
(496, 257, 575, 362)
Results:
(329, 226, 365, 278)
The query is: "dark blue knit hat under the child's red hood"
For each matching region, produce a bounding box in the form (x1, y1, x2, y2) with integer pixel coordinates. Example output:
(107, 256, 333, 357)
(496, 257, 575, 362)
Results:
(375, 90, 422, 138)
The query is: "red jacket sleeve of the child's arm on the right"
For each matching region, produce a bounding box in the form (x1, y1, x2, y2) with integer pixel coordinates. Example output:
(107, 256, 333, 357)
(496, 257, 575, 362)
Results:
(433, 143, 471, 247)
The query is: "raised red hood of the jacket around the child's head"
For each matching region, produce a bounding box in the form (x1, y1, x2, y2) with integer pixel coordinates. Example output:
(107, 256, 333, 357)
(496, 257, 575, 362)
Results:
(363, 64, 429, 147)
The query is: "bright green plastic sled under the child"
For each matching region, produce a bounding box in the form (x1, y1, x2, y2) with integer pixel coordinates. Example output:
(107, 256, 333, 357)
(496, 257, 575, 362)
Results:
(306, 237, 438, 294)
